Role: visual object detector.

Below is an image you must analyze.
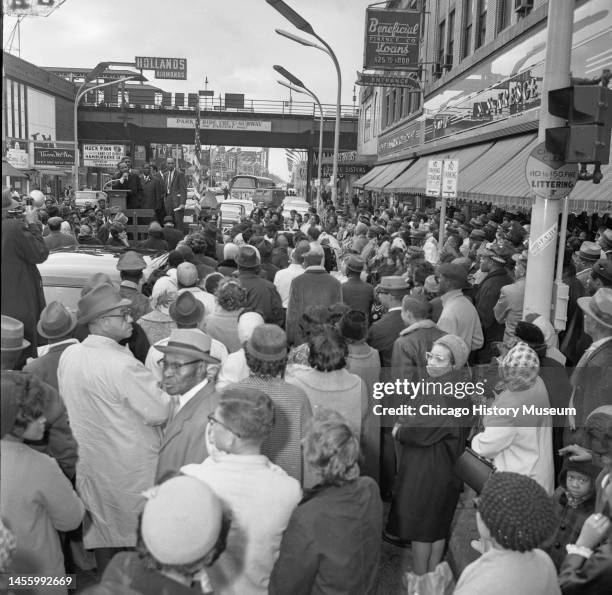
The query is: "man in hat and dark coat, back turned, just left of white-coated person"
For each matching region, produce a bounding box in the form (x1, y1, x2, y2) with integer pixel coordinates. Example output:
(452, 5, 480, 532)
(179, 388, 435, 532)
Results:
(236, 246, 285, 326)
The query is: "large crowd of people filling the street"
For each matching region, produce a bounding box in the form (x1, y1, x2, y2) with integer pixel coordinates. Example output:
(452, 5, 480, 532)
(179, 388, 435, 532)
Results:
(0, 178, 612, 595)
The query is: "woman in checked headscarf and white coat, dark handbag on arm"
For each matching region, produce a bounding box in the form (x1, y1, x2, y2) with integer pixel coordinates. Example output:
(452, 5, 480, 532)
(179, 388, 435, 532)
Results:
(472, 341, 554, 495)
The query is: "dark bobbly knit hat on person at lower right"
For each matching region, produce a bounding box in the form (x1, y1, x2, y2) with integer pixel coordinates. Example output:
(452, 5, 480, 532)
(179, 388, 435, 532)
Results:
(478, 471, 556, 552)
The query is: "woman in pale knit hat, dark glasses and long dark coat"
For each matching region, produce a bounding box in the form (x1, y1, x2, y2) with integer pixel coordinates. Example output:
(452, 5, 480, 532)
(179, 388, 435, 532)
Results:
(386, 335, 472, 575)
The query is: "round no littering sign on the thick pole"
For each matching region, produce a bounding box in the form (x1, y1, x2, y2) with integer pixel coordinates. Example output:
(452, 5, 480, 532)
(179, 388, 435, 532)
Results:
(525, 143, 578, 199)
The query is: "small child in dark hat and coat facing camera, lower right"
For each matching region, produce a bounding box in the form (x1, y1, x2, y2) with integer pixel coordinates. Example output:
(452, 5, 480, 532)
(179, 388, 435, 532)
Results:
(542, 458, 601, 570)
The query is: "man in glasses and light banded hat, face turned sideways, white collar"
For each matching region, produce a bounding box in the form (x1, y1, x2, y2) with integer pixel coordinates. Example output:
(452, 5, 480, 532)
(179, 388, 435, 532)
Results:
(155, 329, 221, 484)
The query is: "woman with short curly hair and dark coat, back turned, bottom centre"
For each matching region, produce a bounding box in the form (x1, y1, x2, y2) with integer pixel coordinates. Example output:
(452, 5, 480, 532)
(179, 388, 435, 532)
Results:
(268, 409, 382, 595)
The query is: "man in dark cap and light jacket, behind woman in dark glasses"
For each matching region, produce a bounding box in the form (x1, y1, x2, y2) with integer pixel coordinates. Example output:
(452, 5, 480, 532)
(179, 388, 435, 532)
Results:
(437, 264, 484, 351)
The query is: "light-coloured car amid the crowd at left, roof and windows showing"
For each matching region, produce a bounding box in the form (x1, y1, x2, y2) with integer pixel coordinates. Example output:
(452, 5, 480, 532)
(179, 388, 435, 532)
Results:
(38, 246, 168, 312)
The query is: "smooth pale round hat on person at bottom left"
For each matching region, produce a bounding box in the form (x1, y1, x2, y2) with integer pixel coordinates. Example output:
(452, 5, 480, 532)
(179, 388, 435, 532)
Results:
(141, 476, 222, 565)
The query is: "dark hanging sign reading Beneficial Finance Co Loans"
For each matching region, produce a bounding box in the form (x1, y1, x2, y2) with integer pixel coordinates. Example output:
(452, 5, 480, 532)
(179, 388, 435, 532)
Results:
(363, 8, 421, 70)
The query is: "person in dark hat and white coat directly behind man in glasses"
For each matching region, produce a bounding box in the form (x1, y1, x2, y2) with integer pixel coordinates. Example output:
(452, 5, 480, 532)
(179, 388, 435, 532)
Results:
(145, 291, 228, 382)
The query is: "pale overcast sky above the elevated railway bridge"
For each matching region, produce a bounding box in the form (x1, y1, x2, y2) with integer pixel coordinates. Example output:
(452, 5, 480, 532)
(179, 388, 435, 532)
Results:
(4, 0, 371, 177)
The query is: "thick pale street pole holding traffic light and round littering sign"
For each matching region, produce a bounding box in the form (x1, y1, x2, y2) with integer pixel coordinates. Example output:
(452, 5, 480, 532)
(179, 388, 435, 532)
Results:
(523, 0, 575, 319)
